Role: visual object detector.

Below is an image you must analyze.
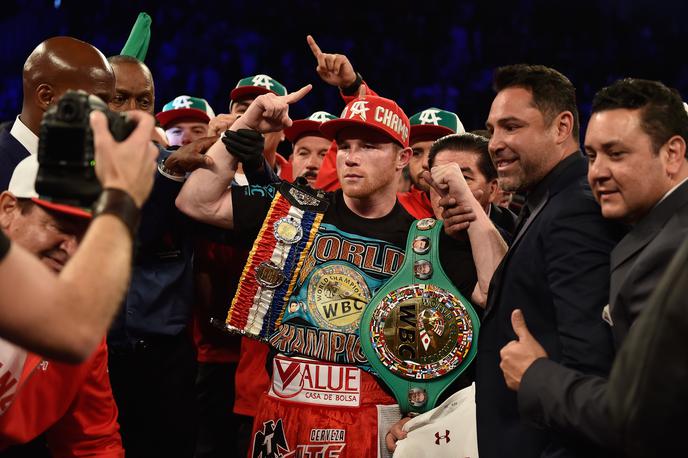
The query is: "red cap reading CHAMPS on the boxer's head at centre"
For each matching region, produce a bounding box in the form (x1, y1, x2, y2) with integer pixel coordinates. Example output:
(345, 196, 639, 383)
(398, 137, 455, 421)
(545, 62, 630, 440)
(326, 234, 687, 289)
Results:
(320, 95, 410, 148)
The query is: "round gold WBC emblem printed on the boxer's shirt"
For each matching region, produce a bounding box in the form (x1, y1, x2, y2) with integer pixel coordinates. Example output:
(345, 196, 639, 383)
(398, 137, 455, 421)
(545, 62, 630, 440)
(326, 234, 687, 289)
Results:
(308, 264, 371, 332)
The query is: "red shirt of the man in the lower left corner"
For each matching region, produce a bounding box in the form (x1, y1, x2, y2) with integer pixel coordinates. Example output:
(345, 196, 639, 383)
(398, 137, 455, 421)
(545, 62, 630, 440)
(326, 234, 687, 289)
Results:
(0, 339, 124, 458)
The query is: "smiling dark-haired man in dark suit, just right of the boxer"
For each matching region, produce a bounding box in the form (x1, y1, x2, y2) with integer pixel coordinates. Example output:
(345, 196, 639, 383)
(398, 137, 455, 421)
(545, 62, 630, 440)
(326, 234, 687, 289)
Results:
(476, 65, 621, 458)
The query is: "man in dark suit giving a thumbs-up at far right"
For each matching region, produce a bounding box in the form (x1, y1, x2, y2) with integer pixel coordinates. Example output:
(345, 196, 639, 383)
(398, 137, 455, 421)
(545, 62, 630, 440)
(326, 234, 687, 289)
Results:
(502, 79, 688, 449)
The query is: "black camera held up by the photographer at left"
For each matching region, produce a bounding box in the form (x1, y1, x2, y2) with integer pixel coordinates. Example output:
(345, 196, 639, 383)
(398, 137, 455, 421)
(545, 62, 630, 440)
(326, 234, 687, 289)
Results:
(36, 90, 136, 207)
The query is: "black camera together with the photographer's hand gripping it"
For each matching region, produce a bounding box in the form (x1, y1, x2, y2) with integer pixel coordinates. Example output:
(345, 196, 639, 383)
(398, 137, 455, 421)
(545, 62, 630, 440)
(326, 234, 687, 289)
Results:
(36, 91, 158, 208)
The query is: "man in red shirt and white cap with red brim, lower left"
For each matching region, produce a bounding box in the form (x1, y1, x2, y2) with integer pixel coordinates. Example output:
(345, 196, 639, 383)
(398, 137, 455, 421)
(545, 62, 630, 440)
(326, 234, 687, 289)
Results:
(0, 156, 124, 457)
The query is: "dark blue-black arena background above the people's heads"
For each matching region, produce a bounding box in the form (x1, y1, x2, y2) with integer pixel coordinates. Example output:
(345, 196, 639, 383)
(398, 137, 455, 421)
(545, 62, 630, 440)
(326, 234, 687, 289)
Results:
(0, 0, 688, 136)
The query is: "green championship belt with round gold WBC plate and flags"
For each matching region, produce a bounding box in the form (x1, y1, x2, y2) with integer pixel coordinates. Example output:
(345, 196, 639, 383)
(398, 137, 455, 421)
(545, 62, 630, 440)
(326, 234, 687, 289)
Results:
(360, 218, 480, 413)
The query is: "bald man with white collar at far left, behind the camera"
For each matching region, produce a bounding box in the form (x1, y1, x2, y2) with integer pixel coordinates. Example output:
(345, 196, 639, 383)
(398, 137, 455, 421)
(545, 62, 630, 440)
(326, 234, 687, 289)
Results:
(0, 37, 115, 191)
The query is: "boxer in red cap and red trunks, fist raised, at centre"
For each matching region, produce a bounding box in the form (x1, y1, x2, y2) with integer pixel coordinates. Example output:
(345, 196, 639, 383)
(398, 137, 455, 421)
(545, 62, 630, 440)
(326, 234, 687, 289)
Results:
(177, 73, 501, 456)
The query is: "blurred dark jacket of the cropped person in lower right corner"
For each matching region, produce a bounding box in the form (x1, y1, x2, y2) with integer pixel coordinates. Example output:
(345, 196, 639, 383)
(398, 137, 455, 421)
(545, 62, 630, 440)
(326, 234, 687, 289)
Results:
(607, 233, 688, 457)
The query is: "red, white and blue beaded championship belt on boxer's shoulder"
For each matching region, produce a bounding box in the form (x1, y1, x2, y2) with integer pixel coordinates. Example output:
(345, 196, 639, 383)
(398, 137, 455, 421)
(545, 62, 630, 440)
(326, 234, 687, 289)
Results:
(220, 182, 328, 341)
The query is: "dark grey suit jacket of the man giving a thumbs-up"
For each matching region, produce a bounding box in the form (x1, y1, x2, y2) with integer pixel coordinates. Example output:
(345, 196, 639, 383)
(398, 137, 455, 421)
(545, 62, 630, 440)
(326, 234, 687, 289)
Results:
(518, 178, 688, 450)
